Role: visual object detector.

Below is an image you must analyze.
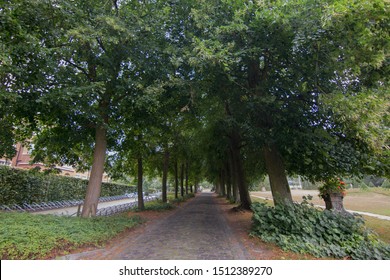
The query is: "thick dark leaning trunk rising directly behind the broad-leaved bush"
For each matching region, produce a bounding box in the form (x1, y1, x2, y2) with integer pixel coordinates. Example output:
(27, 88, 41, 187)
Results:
(263, 145, 292, 204)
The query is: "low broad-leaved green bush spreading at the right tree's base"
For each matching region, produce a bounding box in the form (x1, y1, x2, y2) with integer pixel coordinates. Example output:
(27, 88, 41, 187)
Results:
(251, 200, 390, 259)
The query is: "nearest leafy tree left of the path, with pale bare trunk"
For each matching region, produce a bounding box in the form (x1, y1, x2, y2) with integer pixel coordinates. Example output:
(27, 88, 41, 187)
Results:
(1, 0, 177, 217)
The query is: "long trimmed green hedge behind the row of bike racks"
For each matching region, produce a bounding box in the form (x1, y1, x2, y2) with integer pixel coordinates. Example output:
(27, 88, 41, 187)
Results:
(0, 166, 136, 205)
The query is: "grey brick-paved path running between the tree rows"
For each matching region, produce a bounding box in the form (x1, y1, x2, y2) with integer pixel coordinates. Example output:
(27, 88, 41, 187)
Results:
(63, 193, 249, 260)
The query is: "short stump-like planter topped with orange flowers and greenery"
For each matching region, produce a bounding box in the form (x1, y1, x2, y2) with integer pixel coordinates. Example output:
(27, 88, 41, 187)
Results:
(319, 178, 347, 214)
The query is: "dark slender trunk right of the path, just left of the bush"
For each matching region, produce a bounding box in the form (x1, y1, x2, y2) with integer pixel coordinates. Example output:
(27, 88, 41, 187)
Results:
(230, 131, 252, 210)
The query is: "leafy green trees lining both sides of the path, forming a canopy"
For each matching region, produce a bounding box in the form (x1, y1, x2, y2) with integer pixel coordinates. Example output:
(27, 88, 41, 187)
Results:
(0, 0, 390, 217)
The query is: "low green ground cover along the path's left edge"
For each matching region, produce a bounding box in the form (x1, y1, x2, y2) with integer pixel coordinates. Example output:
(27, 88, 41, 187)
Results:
(0, 212, 141, 260)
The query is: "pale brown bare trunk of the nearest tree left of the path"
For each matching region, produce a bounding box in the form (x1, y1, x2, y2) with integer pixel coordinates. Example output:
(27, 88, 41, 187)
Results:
(81, 126, 107, 218)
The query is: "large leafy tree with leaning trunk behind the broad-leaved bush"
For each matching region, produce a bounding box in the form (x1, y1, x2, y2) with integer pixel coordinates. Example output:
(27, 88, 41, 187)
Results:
(188, 0, 388, 206)
